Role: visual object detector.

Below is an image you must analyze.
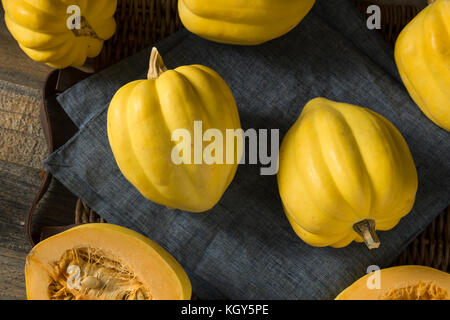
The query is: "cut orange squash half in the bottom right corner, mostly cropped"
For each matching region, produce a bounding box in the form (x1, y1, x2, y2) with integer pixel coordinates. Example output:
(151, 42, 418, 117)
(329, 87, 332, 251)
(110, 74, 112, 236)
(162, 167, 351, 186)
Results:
(336, 266, 450, 300)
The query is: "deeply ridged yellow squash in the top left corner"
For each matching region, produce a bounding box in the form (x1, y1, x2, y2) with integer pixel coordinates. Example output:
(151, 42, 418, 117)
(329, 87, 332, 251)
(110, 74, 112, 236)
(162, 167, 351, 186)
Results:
(2, 0, 117, 69)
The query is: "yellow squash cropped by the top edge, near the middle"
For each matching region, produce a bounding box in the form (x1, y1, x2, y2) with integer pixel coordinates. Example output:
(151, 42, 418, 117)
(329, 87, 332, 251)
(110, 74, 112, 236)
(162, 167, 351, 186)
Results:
(178, 0, 315, 45)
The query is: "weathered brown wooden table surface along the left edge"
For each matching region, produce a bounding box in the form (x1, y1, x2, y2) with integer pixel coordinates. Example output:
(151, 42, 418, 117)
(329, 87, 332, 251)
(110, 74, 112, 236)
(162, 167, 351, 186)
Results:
(0, 5, 75, 299)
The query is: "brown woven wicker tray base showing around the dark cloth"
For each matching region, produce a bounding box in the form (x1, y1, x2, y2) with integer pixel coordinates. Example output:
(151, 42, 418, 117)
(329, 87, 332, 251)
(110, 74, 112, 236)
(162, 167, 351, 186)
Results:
(68, 0, 450, 271)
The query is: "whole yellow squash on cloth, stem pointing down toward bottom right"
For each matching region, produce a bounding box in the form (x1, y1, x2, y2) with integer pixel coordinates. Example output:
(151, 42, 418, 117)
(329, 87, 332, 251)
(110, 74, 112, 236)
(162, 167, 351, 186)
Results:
(278, 98, 418, 249)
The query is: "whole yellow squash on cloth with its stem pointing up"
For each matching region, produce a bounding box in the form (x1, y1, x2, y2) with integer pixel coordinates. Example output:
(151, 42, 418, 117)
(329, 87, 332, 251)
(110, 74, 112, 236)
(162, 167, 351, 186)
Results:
(108, 48, 242, 212)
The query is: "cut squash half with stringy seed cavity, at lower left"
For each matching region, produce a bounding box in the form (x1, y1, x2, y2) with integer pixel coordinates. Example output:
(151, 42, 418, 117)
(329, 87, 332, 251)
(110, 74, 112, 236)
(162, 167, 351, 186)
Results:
(25, 223, 192, 300)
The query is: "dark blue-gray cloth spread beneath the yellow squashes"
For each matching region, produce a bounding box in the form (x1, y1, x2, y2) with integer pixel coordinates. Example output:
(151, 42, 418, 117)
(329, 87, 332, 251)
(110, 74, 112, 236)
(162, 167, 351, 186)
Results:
(45, 0, 450, 299)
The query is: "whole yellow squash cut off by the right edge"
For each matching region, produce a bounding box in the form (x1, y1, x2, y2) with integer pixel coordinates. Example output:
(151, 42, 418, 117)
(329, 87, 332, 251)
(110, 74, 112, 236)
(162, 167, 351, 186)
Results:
(395, 0, 450, 131)
